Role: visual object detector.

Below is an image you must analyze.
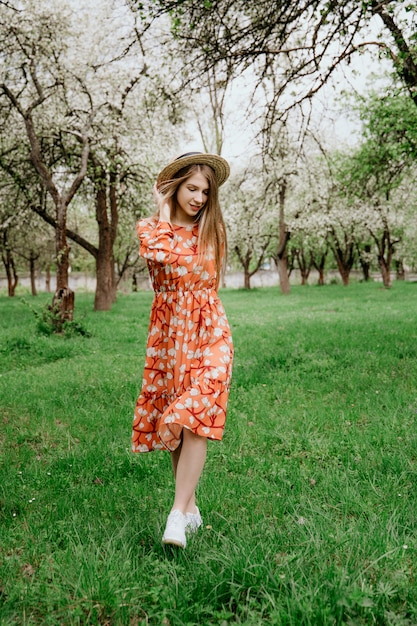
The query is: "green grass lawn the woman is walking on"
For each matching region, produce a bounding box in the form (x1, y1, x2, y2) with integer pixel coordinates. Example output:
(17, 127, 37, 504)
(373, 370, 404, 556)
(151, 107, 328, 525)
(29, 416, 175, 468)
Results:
(0, 283, 417, 626)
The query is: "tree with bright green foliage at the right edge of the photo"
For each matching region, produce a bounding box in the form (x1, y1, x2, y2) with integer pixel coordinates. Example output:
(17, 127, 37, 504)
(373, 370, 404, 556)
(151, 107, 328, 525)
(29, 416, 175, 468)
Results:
(338, 92, 417, 288)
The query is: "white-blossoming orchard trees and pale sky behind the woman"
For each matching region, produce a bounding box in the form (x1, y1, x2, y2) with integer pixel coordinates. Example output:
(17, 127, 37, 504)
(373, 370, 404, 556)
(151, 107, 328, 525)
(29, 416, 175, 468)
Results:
(0, 0, 417, 316)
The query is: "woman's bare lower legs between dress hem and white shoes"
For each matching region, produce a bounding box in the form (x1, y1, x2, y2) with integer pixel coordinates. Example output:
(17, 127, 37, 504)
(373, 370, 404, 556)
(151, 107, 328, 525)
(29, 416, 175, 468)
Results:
(171, 428, 207, 514)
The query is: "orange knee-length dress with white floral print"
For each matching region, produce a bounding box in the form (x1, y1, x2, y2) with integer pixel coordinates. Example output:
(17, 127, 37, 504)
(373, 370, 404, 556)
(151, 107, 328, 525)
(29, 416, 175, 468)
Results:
(132, 217, 233, 452)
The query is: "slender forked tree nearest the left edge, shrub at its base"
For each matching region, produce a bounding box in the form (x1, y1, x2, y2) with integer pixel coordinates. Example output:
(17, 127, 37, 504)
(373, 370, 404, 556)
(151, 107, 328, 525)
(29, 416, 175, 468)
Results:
(0, 4, 93, 328)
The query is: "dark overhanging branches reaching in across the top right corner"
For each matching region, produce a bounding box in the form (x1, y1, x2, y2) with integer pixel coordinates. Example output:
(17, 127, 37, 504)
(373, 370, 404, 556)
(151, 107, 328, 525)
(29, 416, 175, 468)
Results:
(139, 0, 417, 116)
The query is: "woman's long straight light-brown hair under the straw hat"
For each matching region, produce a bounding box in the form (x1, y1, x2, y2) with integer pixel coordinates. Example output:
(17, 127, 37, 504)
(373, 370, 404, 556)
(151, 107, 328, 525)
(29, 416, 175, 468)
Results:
(159, 164, 227, 286)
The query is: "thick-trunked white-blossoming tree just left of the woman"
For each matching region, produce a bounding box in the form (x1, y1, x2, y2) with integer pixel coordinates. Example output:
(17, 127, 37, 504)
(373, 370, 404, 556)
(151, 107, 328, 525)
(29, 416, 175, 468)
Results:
(0, 2, 184, 310)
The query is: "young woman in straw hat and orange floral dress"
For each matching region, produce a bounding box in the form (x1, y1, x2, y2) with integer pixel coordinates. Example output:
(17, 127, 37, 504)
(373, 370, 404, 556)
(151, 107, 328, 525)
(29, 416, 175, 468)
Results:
(132, 152, 233, 548)
